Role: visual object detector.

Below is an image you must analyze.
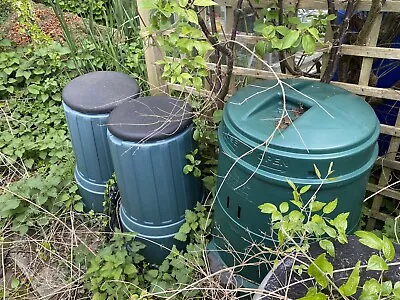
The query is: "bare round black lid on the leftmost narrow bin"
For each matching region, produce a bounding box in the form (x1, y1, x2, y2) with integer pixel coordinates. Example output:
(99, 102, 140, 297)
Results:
(62, 71, 140, 114)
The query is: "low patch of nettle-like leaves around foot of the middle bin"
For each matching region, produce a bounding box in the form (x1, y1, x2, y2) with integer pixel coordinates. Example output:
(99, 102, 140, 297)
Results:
(83, 203, 211, 300)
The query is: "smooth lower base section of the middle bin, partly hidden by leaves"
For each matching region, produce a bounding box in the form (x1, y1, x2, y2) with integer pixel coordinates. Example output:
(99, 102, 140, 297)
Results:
(119, 206, 186, 265)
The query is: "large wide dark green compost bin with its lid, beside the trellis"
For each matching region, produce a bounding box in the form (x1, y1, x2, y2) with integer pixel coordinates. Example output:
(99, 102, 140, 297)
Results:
(210, 80, 380, 282)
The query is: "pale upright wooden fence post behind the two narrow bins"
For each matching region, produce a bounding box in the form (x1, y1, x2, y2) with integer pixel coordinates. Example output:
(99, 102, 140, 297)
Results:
(137, 0, 168, 95)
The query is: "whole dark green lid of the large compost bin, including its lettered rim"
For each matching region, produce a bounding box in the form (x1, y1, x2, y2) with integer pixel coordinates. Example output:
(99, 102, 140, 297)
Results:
(218, 79, 380, 178)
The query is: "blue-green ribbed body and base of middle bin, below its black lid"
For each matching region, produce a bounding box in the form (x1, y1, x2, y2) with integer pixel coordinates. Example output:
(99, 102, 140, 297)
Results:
(109, 127, 201, 262)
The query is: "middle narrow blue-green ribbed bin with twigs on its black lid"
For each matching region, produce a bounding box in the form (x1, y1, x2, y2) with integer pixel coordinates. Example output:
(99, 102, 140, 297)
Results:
(108, 96, 202, 264)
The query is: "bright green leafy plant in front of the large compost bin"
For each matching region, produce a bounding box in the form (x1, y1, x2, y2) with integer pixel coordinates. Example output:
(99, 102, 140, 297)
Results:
(259, 163, 400, 300)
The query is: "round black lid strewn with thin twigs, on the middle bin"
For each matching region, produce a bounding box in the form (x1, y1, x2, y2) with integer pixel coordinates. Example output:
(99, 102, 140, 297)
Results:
(107, 96, 192, 142)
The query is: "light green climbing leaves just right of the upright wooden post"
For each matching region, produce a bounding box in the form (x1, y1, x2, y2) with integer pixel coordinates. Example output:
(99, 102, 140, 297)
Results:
(141, 0, 216, 91)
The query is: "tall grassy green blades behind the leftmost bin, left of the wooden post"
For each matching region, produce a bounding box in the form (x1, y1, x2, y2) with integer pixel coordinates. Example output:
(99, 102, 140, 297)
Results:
(54, 0, 148, 94)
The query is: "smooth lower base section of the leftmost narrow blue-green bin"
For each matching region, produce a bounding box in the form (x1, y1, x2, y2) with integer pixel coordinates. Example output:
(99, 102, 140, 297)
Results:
(74, 167, 106, 213)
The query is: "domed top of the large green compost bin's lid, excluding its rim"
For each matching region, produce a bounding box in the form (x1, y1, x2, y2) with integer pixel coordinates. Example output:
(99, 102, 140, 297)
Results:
(223, 79, 379, 154)
